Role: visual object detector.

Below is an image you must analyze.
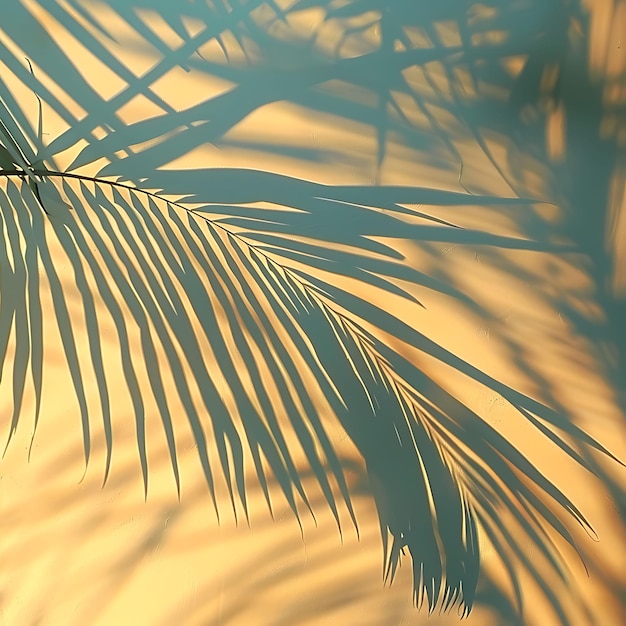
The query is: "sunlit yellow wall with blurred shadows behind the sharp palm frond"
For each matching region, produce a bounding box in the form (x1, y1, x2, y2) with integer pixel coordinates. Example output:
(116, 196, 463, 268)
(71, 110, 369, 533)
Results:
(0, 0, 626, 626)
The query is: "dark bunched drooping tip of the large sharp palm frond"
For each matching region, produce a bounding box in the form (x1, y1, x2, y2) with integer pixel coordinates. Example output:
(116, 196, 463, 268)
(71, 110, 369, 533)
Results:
(238, 219, 591, 623)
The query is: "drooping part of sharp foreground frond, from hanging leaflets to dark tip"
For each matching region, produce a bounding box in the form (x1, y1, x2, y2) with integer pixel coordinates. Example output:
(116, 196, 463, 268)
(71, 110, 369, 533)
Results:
(2, 163, 609, 613)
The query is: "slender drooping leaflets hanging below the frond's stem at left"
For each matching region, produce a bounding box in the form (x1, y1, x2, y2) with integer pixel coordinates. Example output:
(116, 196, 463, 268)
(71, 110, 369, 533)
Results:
(2, 173, 356, 523)
